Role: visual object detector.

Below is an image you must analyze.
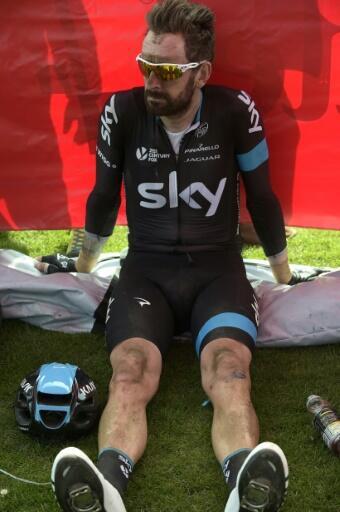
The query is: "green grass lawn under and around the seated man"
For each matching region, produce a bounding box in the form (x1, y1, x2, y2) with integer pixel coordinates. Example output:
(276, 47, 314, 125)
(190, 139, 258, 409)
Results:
(0, 227, 340, 512)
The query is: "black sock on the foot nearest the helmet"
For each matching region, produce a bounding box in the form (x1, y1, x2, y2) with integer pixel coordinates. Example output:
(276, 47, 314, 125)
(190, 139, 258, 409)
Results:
(97, 448, 134, 495)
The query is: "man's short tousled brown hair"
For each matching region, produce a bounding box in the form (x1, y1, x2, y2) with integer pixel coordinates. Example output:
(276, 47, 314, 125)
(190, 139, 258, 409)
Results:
(146, 0, 215, 62)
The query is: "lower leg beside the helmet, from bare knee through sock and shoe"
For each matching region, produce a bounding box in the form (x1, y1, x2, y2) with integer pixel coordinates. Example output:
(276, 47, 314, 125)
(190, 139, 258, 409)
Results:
(52, 338, 162, 512)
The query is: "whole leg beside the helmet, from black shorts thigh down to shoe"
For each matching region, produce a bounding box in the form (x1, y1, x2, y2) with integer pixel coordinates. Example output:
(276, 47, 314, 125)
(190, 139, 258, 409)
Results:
(52, 253, 174, 512)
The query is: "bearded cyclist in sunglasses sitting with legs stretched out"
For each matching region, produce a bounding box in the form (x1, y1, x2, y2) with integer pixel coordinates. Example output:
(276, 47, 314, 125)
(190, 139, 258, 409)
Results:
(38, 0, 304, 512)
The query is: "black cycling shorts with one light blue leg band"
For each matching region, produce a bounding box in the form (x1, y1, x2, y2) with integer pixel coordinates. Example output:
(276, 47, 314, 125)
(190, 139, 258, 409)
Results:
(106, 251, 258, 356)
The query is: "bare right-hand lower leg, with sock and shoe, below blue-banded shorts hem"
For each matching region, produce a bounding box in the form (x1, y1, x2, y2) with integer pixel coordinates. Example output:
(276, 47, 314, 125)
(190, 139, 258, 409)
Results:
(201, 338, 288, 512)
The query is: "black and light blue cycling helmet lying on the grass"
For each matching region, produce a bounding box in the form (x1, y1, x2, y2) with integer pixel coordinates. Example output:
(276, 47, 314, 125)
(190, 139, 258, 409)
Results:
(14, 363, 99, 437)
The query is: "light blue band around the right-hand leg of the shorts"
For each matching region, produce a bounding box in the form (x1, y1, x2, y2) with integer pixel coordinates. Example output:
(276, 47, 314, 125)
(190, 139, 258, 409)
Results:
(195, 313, 257, 356)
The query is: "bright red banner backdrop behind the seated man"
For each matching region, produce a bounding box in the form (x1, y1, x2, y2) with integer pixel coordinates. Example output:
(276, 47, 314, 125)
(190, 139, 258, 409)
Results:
(0, 0, 340, 230)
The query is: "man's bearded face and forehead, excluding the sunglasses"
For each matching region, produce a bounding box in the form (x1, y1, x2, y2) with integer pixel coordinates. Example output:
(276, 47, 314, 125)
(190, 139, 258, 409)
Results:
(142, 31, 195, 116)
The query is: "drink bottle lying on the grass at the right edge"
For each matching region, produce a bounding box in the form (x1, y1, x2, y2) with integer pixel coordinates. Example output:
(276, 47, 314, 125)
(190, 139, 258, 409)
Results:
(306, 395, 340, 457)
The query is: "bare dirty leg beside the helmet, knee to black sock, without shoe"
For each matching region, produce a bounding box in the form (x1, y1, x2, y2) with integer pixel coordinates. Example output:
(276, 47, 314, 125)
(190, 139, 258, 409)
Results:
(98, 338, 162, 493)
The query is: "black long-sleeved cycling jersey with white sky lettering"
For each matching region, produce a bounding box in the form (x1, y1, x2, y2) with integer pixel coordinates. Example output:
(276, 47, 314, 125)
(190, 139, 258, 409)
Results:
(86, 86, 286, 256)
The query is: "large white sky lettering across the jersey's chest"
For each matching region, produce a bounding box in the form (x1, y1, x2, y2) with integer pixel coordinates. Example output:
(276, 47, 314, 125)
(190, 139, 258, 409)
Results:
(138, 171, 227, 217)
